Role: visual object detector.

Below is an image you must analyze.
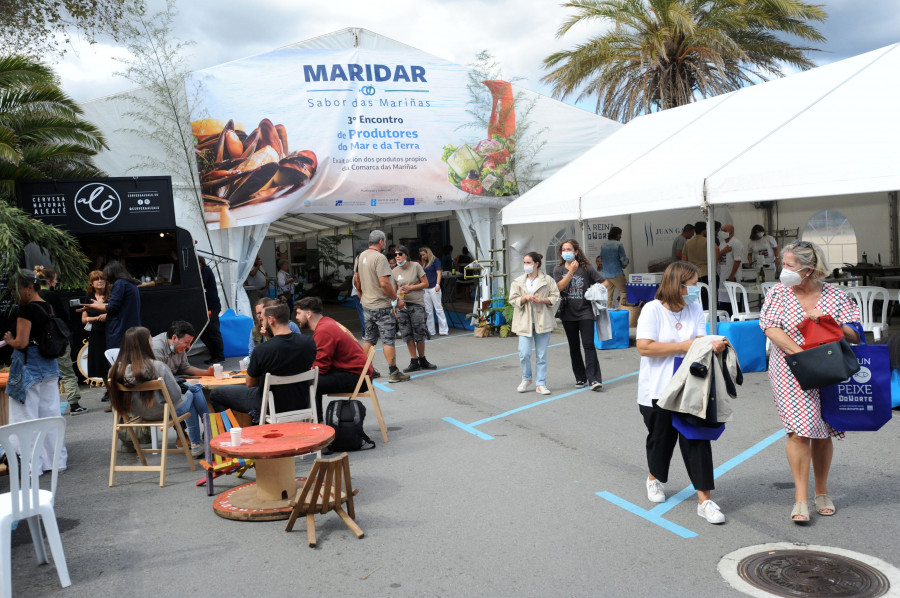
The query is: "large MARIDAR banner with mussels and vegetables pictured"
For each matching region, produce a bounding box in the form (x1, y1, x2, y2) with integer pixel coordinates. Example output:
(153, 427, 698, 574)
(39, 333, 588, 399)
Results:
(187, 49, 518, 229)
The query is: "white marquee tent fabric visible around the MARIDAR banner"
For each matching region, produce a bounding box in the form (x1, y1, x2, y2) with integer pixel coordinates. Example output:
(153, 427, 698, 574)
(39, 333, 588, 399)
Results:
(82, 27, 622, 311)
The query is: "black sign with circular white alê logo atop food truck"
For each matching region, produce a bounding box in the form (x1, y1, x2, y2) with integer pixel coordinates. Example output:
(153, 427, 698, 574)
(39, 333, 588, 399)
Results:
(16, 177, 175, 234)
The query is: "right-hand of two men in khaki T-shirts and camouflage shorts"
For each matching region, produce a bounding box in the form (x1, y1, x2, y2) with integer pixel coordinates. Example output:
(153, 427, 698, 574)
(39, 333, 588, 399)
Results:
(391, 245, 437, 373)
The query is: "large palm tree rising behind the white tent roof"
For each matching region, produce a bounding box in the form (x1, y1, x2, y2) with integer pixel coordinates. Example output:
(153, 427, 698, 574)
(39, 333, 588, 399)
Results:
(542, 0, 828, 122)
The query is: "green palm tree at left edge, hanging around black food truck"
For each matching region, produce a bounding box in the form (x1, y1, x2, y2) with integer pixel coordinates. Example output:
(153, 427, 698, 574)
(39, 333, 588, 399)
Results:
(0, 56, 107, 292)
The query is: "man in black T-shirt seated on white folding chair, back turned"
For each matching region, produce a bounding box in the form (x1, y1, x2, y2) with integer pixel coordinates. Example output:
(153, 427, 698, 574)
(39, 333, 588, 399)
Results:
(209, 303, 316, 424)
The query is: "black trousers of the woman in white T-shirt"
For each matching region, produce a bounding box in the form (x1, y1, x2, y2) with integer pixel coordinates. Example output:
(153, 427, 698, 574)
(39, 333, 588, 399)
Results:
(638, 401, 716, 490)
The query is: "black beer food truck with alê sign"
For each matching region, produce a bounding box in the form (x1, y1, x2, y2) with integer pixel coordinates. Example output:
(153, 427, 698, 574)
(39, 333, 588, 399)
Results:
(16, 176, 209, 373)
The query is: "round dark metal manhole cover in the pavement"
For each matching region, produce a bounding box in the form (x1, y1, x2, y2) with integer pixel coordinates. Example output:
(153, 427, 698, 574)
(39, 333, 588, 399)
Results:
(738, 550, 891, 598)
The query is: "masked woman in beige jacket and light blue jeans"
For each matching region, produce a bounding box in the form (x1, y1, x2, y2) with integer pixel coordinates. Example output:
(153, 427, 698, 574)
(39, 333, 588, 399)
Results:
(509, 251, 559, 395)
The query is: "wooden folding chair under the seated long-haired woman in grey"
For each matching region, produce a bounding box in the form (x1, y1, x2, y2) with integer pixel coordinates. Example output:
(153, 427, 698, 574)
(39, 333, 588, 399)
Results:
(109, 378, 197, 487)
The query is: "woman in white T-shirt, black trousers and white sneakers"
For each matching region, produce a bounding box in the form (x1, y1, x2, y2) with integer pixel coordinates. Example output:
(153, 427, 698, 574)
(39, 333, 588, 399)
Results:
(637, 262, 727, 523)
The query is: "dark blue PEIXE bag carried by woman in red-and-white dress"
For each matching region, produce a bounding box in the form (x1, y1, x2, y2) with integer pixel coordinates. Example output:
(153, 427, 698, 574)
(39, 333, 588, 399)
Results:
(821, 345, 891, 432)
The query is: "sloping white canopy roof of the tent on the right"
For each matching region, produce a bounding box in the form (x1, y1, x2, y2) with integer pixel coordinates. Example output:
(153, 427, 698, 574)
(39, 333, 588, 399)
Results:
(503, 44, 900, 224)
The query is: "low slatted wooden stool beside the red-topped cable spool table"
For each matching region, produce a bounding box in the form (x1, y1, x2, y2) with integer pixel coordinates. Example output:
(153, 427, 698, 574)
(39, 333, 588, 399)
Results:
(284, 453, 364, 548)
